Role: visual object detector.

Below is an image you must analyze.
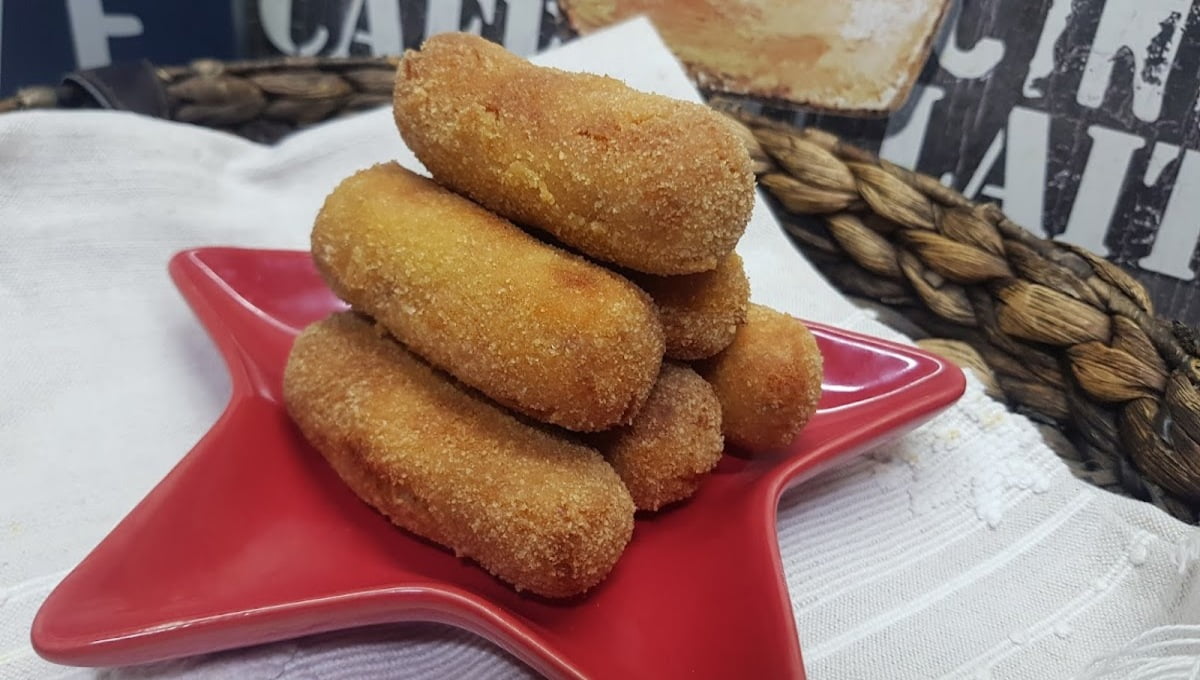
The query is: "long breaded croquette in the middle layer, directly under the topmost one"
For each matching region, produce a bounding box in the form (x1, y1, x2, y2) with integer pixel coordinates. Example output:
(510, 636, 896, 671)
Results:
(312, 163, 664, 432)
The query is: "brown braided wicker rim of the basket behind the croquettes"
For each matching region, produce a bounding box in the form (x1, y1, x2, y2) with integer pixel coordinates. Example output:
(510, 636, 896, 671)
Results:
(0, 58, 1200, 523)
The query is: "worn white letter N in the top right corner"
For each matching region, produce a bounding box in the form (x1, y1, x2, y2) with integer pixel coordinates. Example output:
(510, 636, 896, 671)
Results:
(1075, 0, 1192, 121)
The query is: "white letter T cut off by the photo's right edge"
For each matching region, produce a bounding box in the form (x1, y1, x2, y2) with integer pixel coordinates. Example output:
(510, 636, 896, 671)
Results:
(1138, 147, 1200, 281)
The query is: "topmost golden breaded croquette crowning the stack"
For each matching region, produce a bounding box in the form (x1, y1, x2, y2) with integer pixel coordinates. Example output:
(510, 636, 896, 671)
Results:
(394, 34, 754, 275)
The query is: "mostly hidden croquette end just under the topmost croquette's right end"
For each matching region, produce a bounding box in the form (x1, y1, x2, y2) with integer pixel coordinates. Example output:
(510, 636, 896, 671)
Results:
(630, 253, 750, 361)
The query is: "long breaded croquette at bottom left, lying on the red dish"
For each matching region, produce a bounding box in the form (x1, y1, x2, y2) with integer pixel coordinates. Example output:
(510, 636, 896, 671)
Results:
(283, 312, 634, 597)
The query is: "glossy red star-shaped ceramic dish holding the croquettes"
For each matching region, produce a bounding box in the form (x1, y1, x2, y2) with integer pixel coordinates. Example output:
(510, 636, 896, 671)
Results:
(32, 248, 964, 679)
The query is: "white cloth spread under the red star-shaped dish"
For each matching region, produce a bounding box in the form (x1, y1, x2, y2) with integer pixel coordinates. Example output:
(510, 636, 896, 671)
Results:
(0, 20, 1200, 680)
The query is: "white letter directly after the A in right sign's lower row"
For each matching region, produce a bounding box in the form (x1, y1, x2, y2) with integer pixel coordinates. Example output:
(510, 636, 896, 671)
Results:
(1058, 125, 1146, 258)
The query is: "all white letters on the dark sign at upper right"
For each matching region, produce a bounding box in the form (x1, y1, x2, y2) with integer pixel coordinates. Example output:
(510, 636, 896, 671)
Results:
(880, 0, 1200, 281)
